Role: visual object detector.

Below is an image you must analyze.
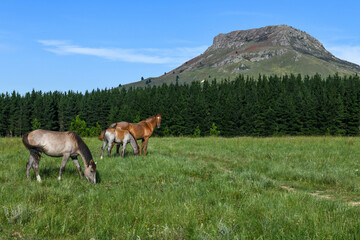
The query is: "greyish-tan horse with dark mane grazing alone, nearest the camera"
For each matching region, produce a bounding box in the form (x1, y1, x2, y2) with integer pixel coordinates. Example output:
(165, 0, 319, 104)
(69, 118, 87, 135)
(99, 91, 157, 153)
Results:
(22, 129, 96, 183)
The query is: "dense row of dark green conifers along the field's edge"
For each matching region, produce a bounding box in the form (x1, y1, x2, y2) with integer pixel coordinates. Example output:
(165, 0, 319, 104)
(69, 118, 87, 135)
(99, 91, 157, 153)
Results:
(0, 74, 360, 136)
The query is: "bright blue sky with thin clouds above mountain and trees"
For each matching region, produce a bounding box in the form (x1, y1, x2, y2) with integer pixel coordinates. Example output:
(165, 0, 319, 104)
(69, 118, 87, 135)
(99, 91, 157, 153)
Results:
(0, 0, 360, 94)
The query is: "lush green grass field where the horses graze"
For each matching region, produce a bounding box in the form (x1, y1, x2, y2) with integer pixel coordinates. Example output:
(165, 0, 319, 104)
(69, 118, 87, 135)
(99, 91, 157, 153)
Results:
(0, 137, 360, 239)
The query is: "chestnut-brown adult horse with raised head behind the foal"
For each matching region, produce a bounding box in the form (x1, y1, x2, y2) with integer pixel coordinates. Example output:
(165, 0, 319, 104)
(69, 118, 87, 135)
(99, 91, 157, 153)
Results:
(109, 113, 161, 156)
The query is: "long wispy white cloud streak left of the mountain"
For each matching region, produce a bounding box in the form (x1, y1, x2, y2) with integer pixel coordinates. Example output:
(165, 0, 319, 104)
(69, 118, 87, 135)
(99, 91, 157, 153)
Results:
(38, 40, 206, 64)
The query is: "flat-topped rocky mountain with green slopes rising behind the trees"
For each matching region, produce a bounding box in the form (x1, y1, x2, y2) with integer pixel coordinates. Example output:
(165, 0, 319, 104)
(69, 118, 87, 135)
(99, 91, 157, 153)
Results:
(127, 25, 360, 87)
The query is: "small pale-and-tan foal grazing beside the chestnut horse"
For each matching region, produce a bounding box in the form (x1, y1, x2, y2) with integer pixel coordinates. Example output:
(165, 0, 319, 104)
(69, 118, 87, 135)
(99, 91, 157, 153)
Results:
(99, 128, 139, 159)
